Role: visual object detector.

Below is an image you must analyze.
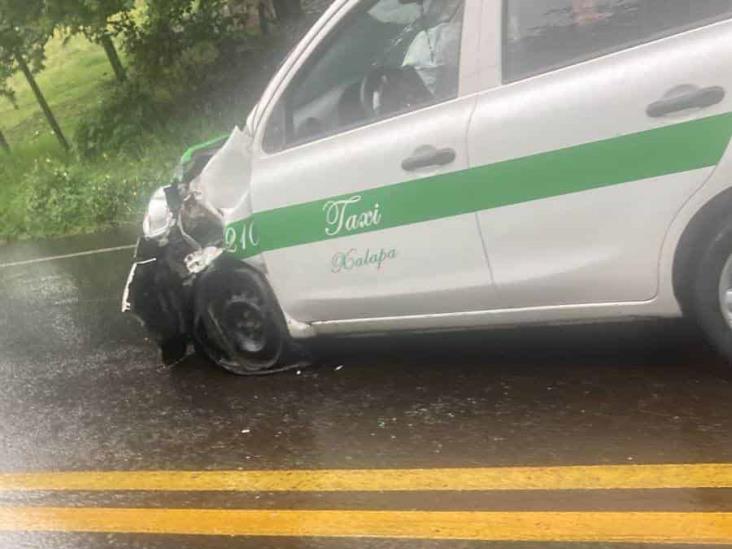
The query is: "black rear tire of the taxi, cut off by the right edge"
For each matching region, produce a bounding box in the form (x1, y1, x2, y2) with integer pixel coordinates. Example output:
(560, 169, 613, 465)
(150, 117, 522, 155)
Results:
(684, 216, 732, 361)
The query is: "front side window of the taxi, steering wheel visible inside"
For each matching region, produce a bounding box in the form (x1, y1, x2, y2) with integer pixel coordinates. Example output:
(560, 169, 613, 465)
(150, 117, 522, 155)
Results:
(264, 0, 463, 152)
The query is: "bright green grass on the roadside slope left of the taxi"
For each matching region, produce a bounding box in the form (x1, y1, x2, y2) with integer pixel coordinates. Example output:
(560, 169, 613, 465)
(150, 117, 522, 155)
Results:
(0, 36, 232, 241)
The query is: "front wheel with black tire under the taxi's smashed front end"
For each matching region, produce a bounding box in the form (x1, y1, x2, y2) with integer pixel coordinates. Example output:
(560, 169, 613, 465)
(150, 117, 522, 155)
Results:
(193, 266, 308, 375)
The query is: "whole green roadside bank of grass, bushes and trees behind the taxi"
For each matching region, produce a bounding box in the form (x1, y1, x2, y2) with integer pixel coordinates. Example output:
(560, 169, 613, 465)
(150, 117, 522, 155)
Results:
(0, 0, 309, 240)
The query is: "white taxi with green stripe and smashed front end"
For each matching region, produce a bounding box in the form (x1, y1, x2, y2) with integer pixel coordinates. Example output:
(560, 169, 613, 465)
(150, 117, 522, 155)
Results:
(128, 0, 732, 373)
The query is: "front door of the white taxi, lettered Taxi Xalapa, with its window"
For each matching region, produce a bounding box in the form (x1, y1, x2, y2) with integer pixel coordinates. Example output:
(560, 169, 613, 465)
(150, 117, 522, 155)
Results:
(251, 0, 491, 321)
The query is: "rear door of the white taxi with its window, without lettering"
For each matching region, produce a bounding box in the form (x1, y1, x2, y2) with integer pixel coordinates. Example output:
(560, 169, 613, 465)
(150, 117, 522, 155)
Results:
(469, 0, 732, 308)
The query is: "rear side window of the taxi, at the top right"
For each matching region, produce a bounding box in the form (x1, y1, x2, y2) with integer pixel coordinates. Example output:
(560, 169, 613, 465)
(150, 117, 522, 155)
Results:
(503, 0, 732, 82)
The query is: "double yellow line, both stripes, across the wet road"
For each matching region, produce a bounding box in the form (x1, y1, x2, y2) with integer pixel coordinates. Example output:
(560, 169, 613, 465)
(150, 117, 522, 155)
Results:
(0, 464, 732, 544)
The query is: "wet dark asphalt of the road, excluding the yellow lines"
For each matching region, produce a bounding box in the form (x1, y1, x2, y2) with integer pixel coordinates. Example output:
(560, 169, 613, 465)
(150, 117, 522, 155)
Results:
(0, 226, 732, 549)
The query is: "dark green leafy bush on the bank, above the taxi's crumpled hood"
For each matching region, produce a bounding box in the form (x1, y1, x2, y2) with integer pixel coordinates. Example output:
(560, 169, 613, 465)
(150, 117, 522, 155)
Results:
(73, 0, 256, 160)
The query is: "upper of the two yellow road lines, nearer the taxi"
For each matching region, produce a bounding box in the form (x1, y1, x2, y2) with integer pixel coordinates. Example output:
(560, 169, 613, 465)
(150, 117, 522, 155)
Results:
(0, 464, 732, 492)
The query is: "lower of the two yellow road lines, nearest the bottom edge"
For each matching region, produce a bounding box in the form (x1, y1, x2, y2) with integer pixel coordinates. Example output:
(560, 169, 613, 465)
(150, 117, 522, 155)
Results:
(0, 507, 732, 544)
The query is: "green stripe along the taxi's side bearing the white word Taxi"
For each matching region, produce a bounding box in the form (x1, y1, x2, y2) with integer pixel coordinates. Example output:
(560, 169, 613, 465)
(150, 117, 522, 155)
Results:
(226, 113, 732, 259)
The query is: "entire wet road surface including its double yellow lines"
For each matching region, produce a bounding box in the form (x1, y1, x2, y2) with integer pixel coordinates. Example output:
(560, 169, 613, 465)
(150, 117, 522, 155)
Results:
(0, 227, 732, 549)
